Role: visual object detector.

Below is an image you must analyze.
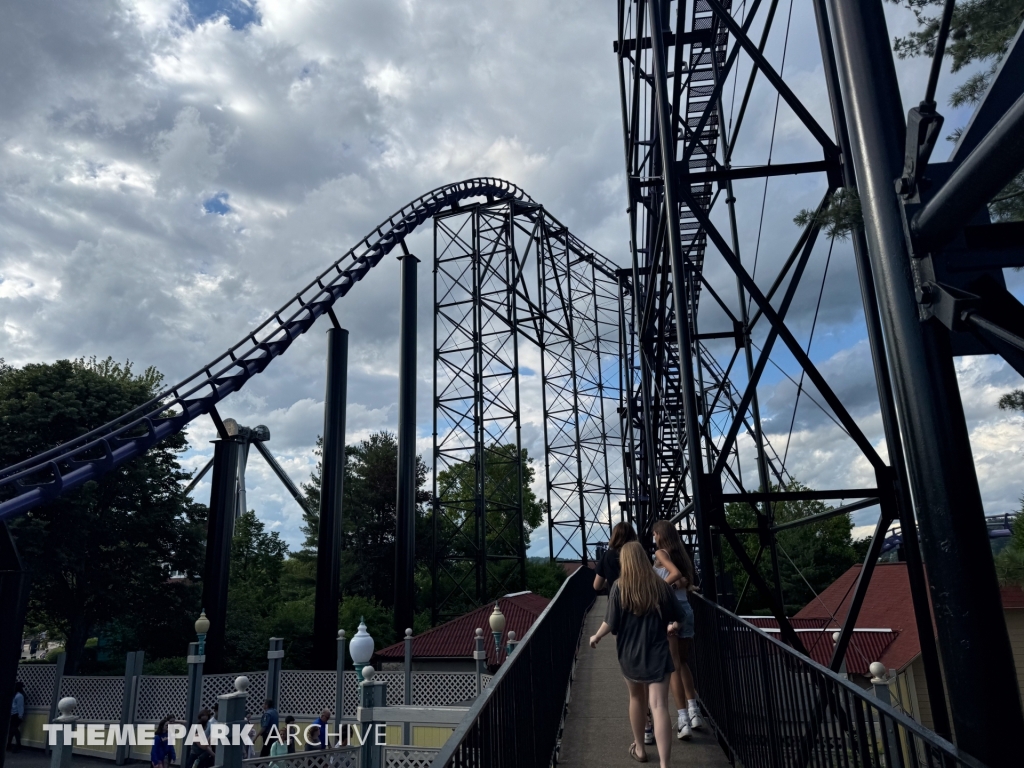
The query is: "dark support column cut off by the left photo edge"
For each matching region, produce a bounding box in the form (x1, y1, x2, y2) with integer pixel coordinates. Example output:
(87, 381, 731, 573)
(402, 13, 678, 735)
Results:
(0, 523, 29, 768)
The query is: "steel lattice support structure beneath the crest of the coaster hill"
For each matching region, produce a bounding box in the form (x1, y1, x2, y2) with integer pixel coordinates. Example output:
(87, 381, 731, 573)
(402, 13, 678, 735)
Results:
(432, 200, 624, 617)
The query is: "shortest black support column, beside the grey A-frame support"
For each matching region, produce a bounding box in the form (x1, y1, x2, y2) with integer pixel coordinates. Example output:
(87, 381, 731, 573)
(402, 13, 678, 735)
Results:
(203, 437, 246, 673)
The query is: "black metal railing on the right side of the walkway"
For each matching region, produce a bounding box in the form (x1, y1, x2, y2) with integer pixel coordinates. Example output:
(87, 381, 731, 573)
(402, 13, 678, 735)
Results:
(691, 596, 984, 768)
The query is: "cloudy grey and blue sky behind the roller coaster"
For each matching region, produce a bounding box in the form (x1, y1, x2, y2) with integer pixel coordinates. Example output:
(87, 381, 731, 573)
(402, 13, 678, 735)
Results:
(0, 0, 1024, 554)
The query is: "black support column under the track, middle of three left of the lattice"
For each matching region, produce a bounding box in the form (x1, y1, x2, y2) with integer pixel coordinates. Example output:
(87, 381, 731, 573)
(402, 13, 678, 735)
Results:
(313, 324, 348, 670)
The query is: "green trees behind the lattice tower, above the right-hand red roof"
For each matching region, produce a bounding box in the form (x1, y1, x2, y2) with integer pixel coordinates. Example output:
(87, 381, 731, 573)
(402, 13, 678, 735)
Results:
(722, 481, 868, 615)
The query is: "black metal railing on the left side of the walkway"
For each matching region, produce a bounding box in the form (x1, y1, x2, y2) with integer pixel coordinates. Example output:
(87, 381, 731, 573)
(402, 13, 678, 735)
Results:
(433, 568, 594, 768)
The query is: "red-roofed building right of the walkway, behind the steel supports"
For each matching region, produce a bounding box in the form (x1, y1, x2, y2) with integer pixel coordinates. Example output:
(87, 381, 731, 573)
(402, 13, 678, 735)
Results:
(745, 562, 1024, 728)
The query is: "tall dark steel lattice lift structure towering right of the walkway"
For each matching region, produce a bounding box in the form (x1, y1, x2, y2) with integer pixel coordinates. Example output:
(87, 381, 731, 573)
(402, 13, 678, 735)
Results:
(614, 0, 1024, 765)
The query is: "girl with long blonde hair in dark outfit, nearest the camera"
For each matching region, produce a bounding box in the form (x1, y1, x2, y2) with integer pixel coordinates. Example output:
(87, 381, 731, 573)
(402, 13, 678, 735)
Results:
(590, 542, 685, 768)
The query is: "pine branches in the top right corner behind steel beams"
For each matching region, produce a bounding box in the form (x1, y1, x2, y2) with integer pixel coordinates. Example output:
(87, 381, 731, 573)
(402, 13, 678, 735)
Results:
(891, 0, 1024, 221)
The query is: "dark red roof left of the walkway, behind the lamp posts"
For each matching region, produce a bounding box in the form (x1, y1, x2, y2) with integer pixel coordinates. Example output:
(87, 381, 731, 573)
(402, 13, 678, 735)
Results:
(376, 592, 551, 666)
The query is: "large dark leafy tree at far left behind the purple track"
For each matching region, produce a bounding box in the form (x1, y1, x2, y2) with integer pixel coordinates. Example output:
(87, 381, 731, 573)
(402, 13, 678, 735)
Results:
(0, 357, 206, 674)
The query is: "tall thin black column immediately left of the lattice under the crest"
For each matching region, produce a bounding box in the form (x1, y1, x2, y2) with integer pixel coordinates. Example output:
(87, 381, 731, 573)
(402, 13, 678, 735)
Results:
(394, 254, 420, 636)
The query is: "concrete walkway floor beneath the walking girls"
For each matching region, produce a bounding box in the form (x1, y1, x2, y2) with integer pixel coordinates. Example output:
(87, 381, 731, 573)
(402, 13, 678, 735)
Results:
(558, 596, 729, 768)
